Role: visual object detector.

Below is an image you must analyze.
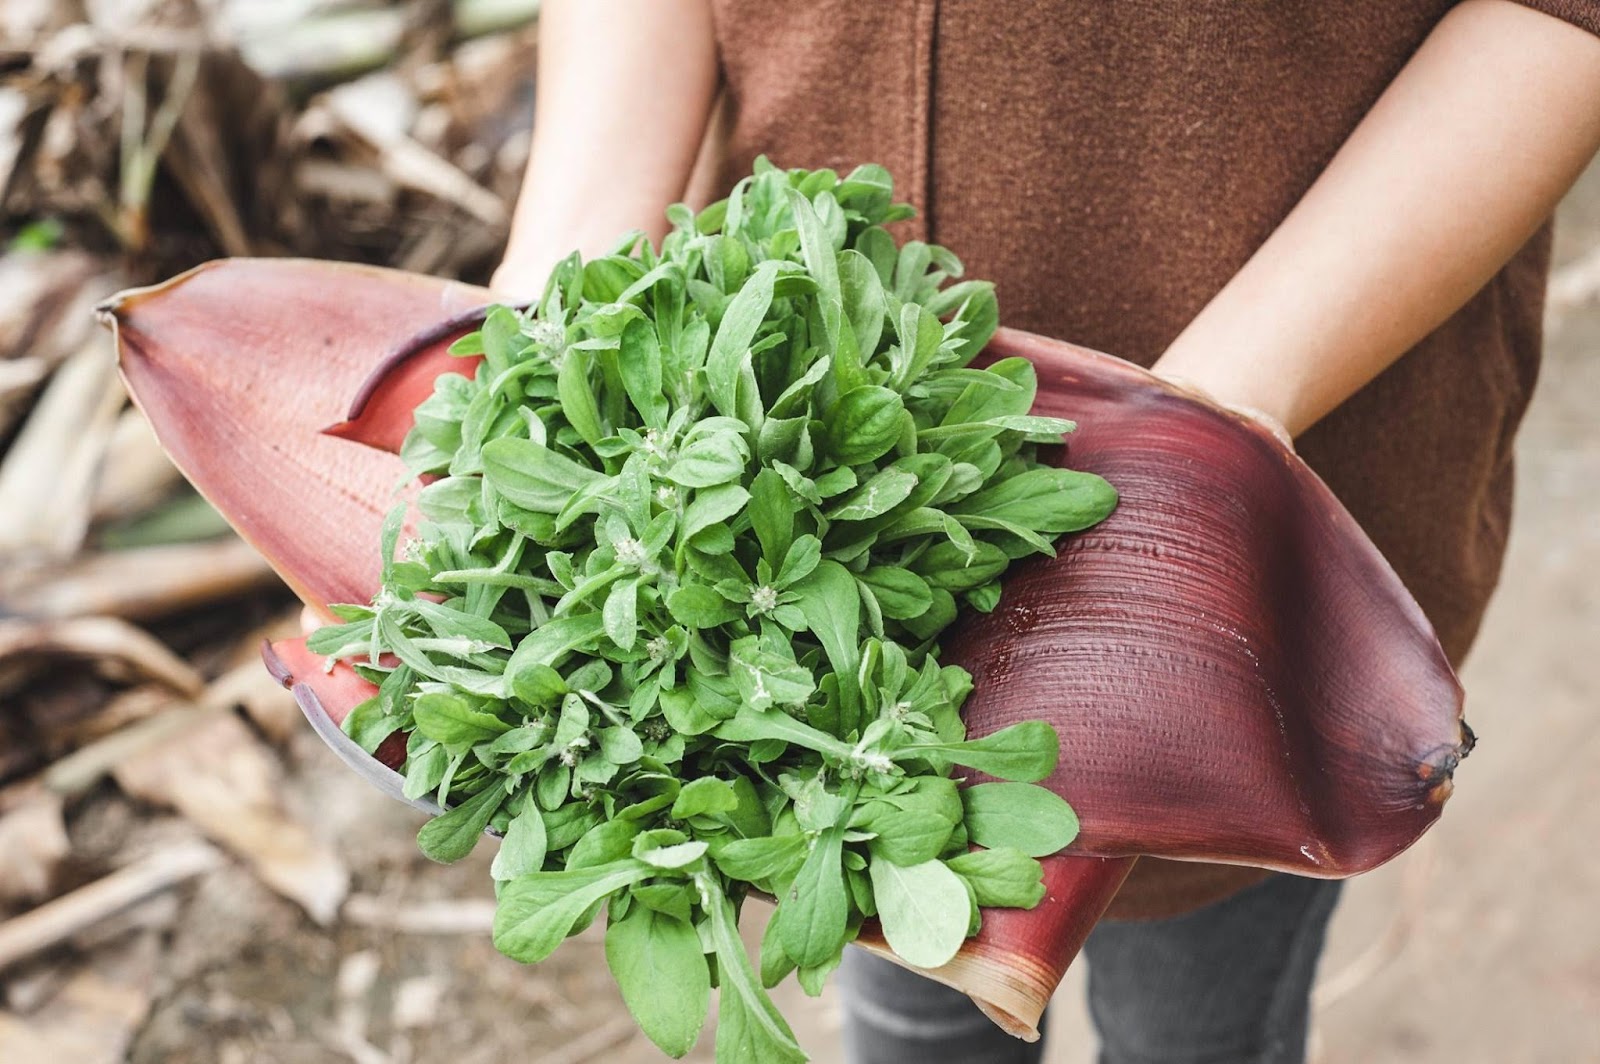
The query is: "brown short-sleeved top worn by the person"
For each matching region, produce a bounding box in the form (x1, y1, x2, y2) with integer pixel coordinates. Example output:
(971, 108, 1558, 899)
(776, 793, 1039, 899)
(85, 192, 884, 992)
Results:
(715, 0, 1600, 917)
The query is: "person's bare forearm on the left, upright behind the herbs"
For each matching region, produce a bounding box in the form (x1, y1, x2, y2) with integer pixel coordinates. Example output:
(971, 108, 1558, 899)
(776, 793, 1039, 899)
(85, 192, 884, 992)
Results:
(491, 0, 717, 298)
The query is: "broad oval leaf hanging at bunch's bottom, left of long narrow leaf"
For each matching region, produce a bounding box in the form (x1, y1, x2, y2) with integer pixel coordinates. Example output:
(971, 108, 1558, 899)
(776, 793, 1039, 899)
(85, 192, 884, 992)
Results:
(605, 906, 710, 1058)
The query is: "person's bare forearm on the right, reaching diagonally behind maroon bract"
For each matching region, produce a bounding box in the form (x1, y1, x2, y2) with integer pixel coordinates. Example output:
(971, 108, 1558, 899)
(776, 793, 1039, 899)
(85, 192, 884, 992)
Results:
(1155, 0, 1600, 434)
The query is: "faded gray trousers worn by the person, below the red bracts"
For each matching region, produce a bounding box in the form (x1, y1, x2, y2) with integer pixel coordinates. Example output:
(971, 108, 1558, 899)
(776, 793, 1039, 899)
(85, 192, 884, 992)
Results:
(840, 875, 1339, 1064)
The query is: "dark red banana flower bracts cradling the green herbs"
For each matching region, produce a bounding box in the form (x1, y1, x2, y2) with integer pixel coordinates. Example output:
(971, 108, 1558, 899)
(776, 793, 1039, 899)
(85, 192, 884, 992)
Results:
(102, 259, 1470, 1037)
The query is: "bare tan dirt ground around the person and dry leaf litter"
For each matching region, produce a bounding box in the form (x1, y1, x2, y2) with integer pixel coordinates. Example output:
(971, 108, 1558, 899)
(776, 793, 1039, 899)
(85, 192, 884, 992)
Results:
(59, 168, 1600, 1064)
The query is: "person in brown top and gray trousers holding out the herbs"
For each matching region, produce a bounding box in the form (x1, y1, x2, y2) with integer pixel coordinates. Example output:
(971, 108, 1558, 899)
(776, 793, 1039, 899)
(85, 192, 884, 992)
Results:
(493, 0, 1600, 1064)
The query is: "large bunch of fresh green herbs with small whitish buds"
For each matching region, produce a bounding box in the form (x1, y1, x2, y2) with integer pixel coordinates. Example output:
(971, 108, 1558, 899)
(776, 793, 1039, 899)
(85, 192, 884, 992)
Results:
(312, 162, 1115, 1062)
